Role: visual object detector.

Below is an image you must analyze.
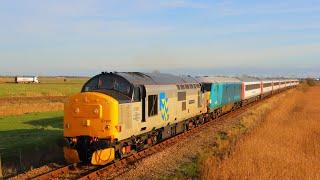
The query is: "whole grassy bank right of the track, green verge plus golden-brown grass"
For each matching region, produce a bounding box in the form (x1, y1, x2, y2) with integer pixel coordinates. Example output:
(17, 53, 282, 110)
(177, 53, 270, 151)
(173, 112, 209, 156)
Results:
(174, 84, 320, 179)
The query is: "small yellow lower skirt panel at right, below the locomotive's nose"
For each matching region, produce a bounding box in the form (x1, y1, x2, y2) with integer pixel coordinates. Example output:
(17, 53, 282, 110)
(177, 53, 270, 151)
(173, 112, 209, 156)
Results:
(91, 148, 115, 165)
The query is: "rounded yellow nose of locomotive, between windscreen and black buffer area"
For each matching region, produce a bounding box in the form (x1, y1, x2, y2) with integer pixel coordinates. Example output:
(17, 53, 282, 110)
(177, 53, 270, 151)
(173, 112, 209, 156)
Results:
(64, 92, 118, 138)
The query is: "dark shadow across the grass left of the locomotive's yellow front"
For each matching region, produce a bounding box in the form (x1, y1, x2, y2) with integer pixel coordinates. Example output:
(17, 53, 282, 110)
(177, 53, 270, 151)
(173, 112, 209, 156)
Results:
(0, 117, 64, 176)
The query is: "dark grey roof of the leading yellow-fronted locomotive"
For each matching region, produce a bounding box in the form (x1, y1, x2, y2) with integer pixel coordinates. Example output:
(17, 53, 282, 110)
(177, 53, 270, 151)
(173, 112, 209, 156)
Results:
(105, 72, 198, 85)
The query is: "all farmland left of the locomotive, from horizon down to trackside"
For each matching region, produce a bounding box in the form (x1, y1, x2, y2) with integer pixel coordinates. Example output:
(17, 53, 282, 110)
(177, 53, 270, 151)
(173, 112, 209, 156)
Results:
(0, 77, 88, 176)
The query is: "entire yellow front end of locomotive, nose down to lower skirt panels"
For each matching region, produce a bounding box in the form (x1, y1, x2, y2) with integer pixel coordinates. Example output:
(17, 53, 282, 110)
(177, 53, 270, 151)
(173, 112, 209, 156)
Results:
(64, 92, 119, 165)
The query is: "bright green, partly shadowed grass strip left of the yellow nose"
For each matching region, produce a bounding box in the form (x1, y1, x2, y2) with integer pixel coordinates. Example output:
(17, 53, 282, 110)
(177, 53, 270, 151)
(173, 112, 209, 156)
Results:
(0, 112, 63, 153)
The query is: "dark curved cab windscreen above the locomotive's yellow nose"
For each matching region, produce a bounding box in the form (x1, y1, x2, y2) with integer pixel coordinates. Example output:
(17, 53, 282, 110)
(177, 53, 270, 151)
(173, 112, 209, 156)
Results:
(82, 74, 133, 100)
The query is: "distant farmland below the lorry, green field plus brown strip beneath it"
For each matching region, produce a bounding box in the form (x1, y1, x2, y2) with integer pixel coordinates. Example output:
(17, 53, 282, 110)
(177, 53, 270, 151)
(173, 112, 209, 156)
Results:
(0, 77, 88, 116)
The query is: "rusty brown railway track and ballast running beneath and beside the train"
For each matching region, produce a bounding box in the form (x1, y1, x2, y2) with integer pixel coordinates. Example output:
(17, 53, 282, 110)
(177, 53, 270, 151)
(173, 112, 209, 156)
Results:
(26, 89, 284, 180)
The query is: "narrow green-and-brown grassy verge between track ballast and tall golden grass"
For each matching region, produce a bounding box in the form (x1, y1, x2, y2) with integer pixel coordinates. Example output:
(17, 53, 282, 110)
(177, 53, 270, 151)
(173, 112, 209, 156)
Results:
(169, 95, 283, 179)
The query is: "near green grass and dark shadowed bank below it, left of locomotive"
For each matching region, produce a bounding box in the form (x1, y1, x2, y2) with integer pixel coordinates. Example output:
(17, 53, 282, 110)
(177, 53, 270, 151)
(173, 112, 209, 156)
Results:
(0, 112, 63, 175)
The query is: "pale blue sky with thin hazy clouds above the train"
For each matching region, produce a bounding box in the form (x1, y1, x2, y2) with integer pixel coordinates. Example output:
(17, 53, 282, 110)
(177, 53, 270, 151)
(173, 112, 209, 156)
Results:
(0, 0, 320, 75)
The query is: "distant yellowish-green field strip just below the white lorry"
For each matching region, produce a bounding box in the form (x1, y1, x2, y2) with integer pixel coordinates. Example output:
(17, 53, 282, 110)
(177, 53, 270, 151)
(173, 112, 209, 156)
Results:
(0, 77, 88, 97)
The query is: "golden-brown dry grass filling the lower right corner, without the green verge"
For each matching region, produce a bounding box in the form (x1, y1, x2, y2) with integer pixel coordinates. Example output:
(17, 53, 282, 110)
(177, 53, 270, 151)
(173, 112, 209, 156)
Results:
(202, 86, 320, 179)
